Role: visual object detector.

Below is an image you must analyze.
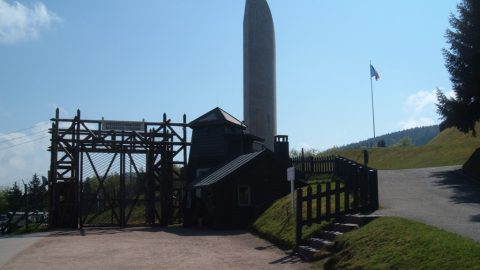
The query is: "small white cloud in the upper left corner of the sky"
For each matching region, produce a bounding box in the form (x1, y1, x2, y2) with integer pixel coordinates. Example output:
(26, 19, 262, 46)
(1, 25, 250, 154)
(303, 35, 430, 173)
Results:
(0, 0, 61, 44)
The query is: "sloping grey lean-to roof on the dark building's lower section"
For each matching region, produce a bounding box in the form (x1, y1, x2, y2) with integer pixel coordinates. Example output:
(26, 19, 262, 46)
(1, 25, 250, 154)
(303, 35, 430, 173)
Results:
(189, 150, 268, 188)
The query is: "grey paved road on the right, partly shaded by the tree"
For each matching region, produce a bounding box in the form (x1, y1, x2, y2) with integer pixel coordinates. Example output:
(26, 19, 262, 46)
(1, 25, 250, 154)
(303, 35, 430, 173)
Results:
(375, 166, 480, 241)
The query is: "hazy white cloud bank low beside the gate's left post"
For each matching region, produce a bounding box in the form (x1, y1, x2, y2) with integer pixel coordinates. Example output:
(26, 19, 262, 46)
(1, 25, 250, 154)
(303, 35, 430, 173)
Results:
(0, 122, 50, 186)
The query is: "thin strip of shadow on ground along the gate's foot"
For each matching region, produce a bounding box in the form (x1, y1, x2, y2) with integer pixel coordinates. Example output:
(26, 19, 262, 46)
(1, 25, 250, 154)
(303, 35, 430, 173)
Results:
(50, 226, 247, 237)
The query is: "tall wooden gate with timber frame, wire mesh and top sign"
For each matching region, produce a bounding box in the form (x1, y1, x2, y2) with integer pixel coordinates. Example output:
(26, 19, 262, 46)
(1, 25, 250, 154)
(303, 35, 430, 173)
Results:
(49, 109, 190, 228)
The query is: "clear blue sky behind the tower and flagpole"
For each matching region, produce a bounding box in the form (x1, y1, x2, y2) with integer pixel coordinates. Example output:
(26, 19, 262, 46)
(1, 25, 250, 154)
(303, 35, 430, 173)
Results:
(0, 0, 459, 185)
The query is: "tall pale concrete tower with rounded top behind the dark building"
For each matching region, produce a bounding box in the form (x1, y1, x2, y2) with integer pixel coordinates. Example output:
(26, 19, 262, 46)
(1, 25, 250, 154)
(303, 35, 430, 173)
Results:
(243, 0, 277, 151)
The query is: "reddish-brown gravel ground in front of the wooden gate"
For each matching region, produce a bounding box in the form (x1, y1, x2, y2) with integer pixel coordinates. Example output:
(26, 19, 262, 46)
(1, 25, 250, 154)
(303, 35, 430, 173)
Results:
(1, 228, 309, 270)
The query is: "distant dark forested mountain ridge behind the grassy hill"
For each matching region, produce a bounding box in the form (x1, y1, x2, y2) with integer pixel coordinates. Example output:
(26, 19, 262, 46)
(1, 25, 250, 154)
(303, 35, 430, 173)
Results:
(338, 125, 440, 150)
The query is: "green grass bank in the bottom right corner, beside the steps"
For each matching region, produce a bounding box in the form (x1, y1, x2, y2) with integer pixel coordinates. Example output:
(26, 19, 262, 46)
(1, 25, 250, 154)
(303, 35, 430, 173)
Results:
(315, 217, 480, 269)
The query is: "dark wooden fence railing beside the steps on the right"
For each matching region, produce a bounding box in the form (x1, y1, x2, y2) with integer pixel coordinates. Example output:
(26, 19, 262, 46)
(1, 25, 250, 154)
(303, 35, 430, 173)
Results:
(295, 156, 378, 244)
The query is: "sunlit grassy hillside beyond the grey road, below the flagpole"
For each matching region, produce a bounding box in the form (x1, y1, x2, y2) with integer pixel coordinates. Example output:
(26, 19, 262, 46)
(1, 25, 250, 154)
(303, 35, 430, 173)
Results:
(323, 124, 480, 169)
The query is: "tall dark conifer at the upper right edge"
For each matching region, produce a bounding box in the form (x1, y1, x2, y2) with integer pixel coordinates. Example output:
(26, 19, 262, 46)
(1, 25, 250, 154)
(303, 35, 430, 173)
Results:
(437, 0, 480, 136)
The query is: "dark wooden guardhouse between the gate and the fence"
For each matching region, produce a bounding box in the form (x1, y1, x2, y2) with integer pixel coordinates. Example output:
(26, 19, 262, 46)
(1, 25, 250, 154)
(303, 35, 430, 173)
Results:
(184, 108, 290, 228)
